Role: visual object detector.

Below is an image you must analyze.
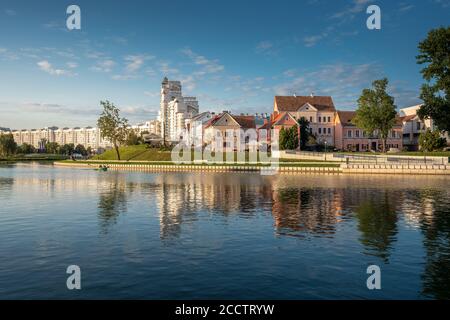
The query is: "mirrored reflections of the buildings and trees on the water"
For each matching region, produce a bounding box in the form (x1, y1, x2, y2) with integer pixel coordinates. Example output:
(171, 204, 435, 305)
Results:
(0, 167, 450, 299)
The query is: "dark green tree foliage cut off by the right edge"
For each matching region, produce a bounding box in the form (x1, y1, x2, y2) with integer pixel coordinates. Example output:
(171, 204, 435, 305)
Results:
(417, 27, 450, 132)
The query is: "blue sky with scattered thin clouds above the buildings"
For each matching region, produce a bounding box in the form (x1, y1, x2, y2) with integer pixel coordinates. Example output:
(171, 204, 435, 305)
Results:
(0, 0, 450, 129)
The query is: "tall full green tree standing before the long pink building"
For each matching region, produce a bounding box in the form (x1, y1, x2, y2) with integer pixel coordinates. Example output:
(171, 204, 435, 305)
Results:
(352, 78, 397, 152)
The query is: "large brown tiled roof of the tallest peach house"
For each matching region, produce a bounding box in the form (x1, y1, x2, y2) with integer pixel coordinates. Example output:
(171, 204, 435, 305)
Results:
(275, 96, 336, 112)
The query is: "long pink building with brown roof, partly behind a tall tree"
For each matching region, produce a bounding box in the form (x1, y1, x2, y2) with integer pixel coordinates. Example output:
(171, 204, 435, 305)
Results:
(334, 111, 403, 151)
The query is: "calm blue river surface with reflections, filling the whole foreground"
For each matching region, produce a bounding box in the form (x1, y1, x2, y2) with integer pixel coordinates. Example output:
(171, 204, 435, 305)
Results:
(0, 164, 450, 299)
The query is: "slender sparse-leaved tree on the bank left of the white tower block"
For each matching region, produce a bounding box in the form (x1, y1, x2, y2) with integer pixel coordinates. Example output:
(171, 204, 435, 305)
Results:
(97, 101, 128, 160)
